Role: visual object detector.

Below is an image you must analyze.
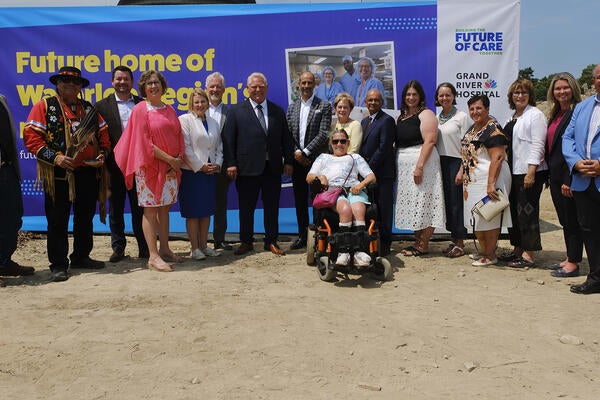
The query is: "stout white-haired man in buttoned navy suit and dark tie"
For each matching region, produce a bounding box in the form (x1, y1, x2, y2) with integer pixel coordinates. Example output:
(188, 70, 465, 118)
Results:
(222, 72, 294, 255)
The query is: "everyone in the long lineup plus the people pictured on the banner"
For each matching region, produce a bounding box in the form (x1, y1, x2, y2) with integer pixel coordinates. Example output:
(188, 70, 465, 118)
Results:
(0, 62, 600, 293)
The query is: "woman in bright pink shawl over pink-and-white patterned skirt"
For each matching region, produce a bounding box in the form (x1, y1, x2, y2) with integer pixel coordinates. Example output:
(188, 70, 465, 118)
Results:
(114, 70, 185, 272)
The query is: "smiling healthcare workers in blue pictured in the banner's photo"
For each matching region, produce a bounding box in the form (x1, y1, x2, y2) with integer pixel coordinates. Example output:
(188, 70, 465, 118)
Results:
(308, 55, 385, 108)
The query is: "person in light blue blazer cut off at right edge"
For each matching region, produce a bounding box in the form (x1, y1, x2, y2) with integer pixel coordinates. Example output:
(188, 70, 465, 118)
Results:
(563, 64, 600, 294)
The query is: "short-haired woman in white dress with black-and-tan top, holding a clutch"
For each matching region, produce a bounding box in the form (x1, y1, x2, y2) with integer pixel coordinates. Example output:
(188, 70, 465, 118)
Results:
(456, 95, 512, 267)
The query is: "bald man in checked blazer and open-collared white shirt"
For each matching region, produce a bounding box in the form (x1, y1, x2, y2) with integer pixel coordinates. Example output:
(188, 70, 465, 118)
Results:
(287, 71, 331, 250)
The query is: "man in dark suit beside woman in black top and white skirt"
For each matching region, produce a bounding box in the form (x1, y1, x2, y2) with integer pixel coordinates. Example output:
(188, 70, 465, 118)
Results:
(360, 89, 396, 256)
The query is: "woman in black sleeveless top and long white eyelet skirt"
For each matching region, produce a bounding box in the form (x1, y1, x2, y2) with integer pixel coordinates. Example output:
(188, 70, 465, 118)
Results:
(394, 80, 445, 256)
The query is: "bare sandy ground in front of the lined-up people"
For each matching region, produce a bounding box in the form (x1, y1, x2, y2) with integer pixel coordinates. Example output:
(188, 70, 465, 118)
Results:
(0, 190, 600, 399)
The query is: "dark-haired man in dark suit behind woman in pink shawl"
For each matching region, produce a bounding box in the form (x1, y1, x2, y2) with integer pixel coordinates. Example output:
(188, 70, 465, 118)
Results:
(96, 66, 148, 263)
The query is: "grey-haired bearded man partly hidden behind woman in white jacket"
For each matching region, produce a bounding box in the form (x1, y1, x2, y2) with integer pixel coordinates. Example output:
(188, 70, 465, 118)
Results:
(205, 72, 231, 250)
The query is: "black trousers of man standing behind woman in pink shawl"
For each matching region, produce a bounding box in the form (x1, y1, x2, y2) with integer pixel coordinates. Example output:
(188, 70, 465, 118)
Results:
(108, 165, 148, 254)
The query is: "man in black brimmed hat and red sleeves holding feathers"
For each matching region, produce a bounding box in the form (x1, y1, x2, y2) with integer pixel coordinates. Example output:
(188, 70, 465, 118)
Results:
(23, 67, 110, 282)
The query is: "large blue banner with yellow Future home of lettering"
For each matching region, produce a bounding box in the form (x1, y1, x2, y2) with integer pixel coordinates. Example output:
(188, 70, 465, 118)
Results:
(0, 2, 437, 233)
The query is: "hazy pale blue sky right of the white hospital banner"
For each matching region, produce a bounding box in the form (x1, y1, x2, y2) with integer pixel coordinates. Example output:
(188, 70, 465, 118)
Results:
(519, 0, 600, 78)
